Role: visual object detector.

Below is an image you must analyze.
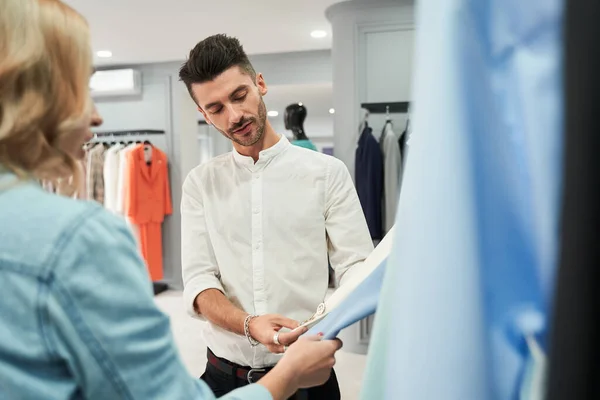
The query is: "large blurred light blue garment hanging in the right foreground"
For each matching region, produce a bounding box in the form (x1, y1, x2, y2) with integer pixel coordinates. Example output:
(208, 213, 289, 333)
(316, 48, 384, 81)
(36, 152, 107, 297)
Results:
(362, 0, 563, 400)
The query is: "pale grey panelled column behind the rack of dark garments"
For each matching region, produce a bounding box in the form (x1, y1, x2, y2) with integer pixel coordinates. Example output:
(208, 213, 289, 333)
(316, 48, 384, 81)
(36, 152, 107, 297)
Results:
(326, 0, 414, 354)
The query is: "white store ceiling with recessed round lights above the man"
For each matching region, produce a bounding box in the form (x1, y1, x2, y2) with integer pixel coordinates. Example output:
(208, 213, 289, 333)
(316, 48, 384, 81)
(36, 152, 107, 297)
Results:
(63, 0, 340, 66)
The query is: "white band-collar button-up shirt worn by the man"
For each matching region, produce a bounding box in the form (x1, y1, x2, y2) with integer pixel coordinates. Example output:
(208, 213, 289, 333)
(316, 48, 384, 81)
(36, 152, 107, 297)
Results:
(181, 136, 373, 368)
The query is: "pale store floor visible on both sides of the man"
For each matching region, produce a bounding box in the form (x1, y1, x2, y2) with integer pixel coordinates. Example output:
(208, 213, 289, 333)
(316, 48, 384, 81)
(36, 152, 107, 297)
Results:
(156, 291, 366, 400)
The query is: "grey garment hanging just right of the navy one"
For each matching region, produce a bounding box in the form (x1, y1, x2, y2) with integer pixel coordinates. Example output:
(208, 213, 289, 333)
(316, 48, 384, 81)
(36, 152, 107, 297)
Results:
(380, 123, 402, 233)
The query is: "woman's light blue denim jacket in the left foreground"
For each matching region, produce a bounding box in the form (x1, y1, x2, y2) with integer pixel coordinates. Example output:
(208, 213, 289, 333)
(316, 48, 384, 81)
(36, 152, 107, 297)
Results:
(0, 173, 271, 400)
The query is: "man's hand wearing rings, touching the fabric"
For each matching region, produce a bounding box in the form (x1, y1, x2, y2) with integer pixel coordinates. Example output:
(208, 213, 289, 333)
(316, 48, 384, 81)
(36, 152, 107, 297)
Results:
(248, 314, 307, 354)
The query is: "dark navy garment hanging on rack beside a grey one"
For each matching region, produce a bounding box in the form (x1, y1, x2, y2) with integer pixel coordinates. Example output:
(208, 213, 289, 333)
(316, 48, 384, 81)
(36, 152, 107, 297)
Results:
(354, 124, 383, 240)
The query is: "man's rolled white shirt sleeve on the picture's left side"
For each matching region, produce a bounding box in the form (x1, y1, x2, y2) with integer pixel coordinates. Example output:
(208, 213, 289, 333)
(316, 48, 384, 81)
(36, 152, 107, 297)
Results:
(181, 171, 225, 320)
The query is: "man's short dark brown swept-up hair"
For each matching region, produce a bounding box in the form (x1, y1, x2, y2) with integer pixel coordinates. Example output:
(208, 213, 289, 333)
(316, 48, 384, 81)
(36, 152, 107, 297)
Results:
(179, 34, 256, 98)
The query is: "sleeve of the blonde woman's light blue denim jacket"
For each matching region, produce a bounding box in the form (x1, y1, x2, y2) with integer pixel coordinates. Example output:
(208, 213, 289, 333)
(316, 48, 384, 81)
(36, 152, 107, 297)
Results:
(41, 210, 271, 400)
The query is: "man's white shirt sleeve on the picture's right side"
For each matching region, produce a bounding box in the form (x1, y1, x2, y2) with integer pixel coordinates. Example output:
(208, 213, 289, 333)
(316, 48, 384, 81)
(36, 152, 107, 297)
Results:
(325, 157, 373, 284)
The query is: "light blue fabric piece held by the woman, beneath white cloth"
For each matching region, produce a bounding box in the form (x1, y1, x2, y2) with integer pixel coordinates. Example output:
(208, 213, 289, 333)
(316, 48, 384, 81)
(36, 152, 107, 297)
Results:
(305, 261, 386, 340)
